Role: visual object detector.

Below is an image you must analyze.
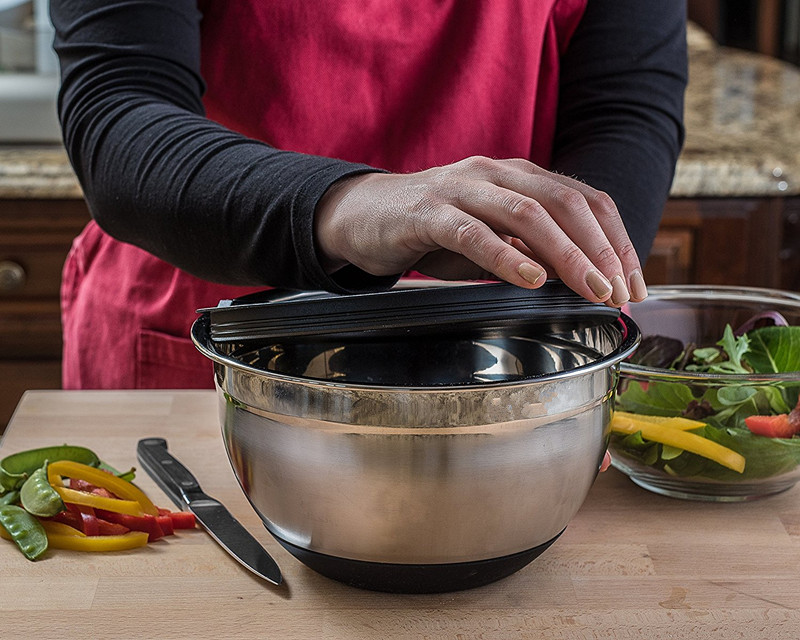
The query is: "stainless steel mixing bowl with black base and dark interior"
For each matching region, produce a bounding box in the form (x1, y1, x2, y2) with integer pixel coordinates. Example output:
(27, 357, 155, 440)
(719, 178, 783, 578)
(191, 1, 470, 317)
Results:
(193, 298, 639, 592)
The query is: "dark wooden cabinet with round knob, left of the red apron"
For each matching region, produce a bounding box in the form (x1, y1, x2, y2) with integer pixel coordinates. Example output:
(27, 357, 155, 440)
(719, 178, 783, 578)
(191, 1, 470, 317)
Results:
(0, 199, 89, 432)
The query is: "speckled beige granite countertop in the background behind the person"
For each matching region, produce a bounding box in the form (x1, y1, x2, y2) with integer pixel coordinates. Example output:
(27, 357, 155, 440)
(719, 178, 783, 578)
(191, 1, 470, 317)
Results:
(0, 24, 800, 198)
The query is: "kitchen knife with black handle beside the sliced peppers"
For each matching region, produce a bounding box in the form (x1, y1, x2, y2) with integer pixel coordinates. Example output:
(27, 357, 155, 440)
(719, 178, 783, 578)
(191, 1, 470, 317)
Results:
(136, 438, 283, 584)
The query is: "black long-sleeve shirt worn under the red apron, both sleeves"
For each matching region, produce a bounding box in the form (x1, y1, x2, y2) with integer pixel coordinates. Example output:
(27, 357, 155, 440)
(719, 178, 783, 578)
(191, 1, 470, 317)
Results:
(51, 0, 687, 291)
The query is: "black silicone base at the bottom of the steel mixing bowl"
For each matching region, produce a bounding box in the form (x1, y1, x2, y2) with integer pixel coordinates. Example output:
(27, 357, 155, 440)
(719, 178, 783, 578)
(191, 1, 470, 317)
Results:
(272, 530, 564, 593)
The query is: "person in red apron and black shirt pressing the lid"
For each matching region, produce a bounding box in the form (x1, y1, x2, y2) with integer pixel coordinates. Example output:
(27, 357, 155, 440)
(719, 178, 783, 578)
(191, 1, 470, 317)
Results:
(50, 0, 687, 388)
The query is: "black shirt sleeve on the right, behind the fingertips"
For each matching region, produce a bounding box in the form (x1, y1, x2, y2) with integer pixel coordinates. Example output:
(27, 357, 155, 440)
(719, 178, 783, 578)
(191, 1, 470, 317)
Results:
(552, 0, 688, 262)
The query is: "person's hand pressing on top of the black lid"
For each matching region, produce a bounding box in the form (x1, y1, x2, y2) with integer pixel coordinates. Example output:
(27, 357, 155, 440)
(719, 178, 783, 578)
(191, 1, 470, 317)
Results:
(315, 157, 647, 307)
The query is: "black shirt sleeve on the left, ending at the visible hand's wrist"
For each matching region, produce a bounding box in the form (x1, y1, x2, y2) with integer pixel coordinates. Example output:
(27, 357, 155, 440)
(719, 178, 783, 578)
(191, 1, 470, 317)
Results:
(50, 0, 396, 291)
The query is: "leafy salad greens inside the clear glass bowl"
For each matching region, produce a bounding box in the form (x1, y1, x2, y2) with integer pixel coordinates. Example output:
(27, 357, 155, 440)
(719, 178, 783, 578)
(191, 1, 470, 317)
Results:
(612, 321, 800, 482)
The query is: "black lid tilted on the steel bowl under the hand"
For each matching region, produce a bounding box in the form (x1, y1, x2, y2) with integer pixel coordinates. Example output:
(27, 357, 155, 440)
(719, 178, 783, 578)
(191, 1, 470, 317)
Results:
(198, 280, 620, 343)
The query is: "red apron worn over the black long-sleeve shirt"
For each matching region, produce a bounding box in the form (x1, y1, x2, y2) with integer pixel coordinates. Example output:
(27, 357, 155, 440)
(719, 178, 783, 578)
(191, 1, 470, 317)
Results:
(62, 0, 586, 389)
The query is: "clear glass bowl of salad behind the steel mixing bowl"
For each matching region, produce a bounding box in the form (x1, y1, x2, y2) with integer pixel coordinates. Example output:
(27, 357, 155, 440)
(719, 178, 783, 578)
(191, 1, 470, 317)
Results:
(609, 285, 800, 502)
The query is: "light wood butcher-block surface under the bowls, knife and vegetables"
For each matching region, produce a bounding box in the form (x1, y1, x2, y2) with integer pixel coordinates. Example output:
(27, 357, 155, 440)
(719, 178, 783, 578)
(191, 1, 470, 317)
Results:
(0, 391, 800, 640)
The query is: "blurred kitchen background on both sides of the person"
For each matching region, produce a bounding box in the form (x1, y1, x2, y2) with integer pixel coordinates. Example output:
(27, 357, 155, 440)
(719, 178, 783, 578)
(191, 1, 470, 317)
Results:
(0, 0, 800, 432)
